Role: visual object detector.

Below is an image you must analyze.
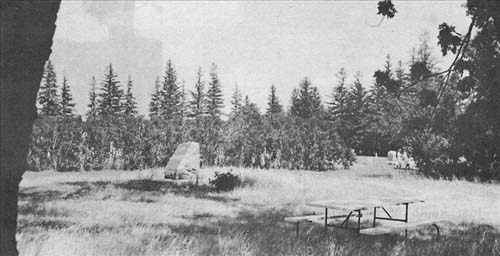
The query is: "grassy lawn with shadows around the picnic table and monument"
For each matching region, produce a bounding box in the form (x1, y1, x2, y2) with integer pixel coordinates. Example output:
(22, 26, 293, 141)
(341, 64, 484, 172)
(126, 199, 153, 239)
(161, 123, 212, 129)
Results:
(17, 157, 500, 256)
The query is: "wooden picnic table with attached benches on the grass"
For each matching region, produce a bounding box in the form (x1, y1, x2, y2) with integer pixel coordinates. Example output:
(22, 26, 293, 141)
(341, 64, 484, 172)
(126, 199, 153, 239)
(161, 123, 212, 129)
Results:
(285, 197, 443, 240)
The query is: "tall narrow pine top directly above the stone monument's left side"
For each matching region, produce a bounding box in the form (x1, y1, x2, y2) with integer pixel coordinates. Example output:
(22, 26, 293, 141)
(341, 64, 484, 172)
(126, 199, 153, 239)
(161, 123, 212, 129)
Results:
(160, 59, 181, 120)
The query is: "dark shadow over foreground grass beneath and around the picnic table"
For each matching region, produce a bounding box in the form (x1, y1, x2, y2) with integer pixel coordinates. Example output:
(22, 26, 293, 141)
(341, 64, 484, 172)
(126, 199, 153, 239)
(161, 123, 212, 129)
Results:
(162, 209, 500, 255)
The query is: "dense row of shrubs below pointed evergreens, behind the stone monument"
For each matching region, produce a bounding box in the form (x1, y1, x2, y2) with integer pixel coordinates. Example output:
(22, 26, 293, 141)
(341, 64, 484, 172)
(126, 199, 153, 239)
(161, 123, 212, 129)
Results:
(28, 114, 354, 171)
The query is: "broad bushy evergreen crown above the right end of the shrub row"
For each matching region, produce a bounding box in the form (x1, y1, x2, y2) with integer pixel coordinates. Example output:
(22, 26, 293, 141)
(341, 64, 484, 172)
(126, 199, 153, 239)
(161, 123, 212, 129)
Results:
(290, 77, 323, 118)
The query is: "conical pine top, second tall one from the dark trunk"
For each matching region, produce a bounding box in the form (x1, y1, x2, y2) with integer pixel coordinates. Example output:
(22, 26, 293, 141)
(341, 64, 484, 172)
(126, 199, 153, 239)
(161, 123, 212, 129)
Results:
(98, 64, 123, 116)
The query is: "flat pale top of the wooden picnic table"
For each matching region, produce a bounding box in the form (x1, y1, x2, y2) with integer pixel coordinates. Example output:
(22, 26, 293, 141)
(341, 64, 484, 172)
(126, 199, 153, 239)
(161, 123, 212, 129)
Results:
(306, 197, 424, 211)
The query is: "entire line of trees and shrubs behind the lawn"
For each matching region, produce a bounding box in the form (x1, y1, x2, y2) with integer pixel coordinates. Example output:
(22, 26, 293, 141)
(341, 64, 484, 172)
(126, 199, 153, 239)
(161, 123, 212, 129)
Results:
(29, 23, 500, 179)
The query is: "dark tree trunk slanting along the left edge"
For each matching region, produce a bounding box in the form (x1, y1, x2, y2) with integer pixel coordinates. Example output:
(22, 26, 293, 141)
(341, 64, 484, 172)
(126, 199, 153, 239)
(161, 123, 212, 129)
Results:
(0, 0, 60, 255)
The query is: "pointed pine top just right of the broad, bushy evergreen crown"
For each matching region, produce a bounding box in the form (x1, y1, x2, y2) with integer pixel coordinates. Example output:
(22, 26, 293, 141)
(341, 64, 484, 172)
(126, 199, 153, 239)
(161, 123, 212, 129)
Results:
(328, 68, 349, 117)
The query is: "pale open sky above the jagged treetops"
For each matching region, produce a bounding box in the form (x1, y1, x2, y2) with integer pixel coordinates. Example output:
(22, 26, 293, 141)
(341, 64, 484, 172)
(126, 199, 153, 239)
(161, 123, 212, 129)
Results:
(51, 0, 470, 115)
